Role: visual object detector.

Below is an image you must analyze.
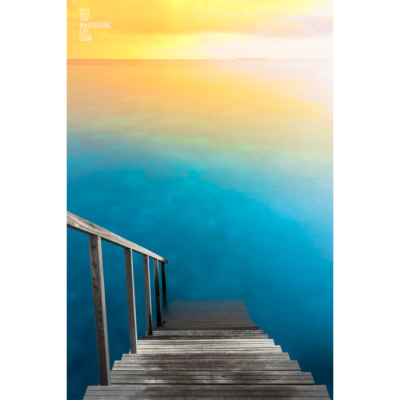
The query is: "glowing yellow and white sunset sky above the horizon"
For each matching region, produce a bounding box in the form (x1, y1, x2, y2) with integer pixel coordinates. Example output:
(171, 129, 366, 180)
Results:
(66, 0, 334, 59)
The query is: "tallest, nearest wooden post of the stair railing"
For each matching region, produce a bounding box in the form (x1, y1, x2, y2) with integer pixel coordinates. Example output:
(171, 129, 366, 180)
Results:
(89, 234, 111, 386)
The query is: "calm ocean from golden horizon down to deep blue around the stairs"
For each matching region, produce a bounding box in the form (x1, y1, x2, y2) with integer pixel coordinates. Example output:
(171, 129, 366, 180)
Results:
(66, 60, 334, 400)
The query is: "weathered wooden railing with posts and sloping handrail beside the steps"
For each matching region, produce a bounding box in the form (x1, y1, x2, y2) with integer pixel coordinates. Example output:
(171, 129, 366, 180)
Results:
(66, 211, 168, 386)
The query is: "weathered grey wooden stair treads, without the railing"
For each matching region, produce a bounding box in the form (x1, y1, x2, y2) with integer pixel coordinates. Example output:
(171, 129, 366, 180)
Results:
(85, 300, 329, 400)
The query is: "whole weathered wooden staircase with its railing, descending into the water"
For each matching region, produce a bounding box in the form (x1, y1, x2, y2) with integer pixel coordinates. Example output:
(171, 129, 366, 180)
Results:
(66, 211, 329, 400)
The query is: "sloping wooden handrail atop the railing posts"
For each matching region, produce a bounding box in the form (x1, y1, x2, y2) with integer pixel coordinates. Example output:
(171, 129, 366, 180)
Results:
(66, 211, 168, 264)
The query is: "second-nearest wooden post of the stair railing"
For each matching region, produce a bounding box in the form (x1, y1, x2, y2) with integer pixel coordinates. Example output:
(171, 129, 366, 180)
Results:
(124, 248, 137, 354)
